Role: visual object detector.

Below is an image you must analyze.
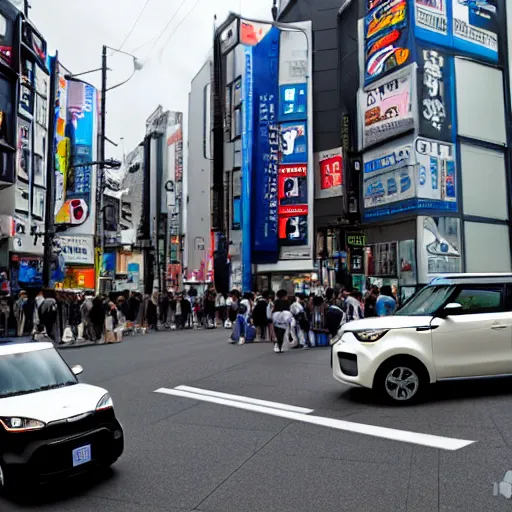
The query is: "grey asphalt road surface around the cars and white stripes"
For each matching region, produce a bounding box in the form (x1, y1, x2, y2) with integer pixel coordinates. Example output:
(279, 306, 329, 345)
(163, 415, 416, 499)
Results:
(0, 329, 512, 512)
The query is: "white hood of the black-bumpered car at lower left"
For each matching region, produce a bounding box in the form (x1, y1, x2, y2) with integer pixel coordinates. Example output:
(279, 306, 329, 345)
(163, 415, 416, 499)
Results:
(0, 384, 107, 423)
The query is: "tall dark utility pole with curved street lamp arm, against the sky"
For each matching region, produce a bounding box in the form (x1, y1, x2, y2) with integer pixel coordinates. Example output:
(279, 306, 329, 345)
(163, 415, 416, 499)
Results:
(65, 45, 144, 288)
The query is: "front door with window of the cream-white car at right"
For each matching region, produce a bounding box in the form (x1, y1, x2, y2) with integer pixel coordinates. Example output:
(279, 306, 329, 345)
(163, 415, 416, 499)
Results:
(432, 284, 512, 379)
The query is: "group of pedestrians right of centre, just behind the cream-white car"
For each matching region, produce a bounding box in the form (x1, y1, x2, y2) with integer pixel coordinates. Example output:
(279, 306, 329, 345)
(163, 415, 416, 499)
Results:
(225, 286, 397, 353)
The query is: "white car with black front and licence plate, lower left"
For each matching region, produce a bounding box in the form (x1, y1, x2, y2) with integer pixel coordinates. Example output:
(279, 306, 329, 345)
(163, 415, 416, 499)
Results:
(0, 341, 124, 489)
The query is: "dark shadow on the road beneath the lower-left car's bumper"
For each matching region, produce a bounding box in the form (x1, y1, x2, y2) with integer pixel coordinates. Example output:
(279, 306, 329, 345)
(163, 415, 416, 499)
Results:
(0, 468, 119, 510)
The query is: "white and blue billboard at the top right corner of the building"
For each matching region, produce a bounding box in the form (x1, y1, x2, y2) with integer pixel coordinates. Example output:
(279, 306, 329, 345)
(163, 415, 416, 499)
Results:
(452, 0, 498, 62)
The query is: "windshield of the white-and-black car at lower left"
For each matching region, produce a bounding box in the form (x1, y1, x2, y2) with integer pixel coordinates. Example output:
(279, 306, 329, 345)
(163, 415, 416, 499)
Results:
(0, 348, 78, 398)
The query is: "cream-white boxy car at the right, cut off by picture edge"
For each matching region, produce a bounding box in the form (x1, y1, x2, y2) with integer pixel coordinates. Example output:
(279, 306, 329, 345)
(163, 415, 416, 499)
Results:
(331, 274, 512, 403)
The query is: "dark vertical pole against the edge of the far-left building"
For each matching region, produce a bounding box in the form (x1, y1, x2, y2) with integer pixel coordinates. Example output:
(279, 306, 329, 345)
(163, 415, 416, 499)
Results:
(43, 56, 59, 288)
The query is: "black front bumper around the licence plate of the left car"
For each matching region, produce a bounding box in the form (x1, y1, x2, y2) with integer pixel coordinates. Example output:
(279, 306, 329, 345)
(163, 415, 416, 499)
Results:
(0, 412, 124, 485)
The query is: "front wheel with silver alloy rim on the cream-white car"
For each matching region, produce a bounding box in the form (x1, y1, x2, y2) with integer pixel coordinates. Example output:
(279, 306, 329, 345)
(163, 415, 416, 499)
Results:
(373, 357, 429, 405)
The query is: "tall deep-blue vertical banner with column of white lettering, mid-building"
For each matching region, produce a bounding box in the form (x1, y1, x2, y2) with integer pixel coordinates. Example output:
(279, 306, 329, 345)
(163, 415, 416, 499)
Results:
(249, 28, 280, 263)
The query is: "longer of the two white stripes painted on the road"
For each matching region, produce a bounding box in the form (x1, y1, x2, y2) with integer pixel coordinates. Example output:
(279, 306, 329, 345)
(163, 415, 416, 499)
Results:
(155, 388, 475, 451)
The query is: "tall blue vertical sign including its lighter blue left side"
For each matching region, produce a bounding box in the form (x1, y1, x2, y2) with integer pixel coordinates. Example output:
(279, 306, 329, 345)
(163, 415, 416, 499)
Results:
(251, 29, 279, 260)
